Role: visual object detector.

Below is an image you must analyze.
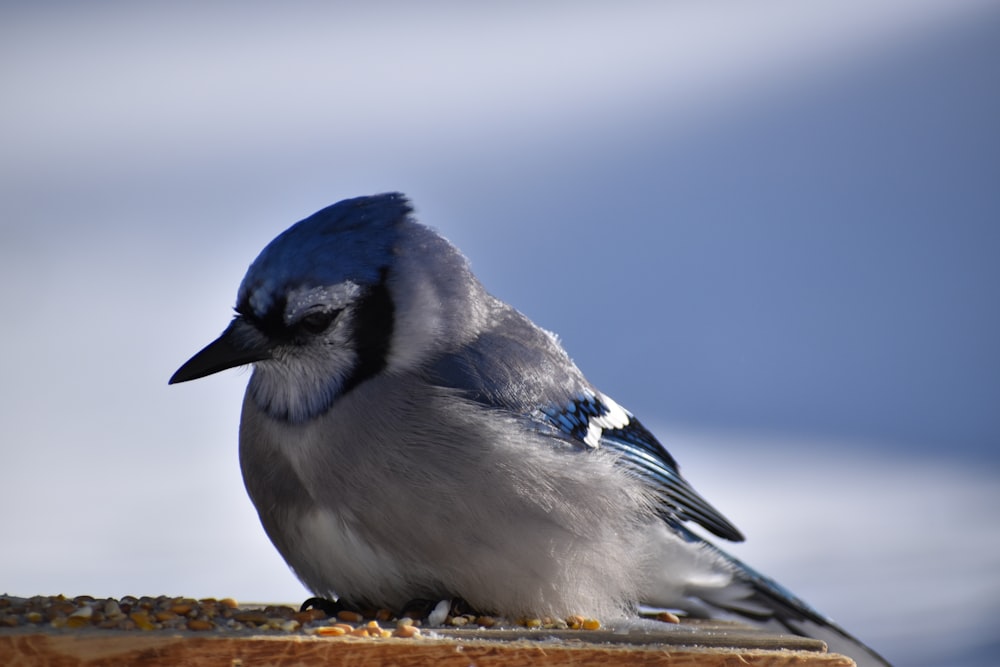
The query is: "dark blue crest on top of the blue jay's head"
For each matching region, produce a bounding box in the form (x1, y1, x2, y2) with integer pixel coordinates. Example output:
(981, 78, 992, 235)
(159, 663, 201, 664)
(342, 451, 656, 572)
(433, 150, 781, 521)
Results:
(237, 192, 413, 317)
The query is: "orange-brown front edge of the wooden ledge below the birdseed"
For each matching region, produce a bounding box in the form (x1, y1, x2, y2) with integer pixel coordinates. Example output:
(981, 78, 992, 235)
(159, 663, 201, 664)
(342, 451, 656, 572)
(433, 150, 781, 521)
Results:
(0, 633, 854, 667)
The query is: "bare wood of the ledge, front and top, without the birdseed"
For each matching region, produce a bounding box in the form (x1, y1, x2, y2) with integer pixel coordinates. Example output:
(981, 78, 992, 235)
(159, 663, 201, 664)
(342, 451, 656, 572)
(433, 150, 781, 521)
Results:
(0, 622, 854, 667)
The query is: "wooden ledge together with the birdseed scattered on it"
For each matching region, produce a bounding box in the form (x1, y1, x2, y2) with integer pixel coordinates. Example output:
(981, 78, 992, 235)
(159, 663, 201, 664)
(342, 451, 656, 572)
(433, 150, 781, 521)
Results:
(0, 596, 854, 667)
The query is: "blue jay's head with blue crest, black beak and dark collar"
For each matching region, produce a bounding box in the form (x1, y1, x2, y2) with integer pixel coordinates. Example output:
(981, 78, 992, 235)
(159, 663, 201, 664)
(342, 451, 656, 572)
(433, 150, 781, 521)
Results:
(170, 193, 478, 422)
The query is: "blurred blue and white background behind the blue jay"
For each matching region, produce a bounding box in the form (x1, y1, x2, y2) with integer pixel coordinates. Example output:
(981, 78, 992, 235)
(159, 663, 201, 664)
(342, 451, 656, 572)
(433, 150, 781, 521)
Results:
(0, 0, 1000, 665)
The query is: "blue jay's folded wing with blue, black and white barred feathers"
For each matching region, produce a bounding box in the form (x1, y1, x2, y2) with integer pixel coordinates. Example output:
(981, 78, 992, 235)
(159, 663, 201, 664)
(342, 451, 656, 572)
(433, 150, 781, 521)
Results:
(430, 311, 743, 542)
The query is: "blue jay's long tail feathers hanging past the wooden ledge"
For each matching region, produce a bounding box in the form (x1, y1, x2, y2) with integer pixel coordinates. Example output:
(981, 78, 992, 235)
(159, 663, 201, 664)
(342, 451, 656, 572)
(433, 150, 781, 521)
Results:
(682, 529, 891, 667)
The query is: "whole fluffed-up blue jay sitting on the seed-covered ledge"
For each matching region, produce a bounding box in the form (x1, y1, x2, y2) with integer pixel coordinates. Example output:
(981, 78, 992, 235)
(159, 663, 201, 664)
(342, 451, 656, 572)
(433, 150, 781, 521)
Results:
(170, 193, 887, 665)
